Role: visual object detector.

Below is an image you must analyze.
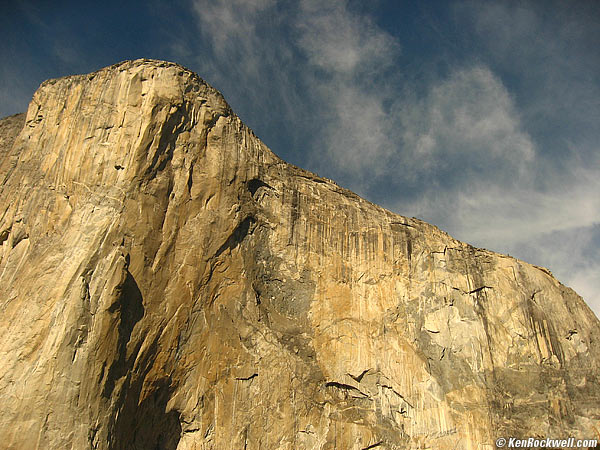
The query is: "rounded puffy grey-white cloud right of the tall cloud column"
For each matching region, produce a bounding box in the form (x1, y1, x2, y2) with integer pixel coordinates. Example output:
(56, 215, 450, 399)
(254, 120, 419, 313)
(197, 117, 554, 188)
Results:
(398, 65, 535, 181)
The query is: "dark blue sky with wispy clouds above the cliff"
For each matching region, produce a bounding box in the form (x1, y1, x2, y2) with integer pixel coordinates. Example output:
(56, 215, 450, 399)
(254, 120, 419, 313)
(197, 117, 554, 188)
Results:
(0, 0, 600, 315)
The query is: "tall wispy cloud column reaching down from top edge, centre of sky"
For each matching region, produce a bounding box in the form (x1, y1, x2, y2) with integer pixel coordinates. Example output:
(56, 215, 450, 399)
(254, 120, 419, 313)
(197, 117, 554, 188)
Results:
(295, 0, 400, 183)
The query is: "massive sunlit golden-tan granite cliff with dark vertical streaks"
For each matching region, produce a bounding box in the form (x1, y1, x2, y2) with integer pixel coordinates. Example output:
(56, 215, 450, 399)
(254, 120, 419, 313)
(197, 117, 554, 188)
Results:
(0, 60, 600, 450)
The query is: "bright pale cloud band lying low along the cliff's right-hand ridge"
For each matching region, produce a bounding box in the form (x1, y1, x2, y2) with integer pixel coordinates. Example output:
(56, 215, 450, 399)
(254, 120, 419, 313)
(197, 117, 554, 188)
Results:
(400, 169, 600, 250)
